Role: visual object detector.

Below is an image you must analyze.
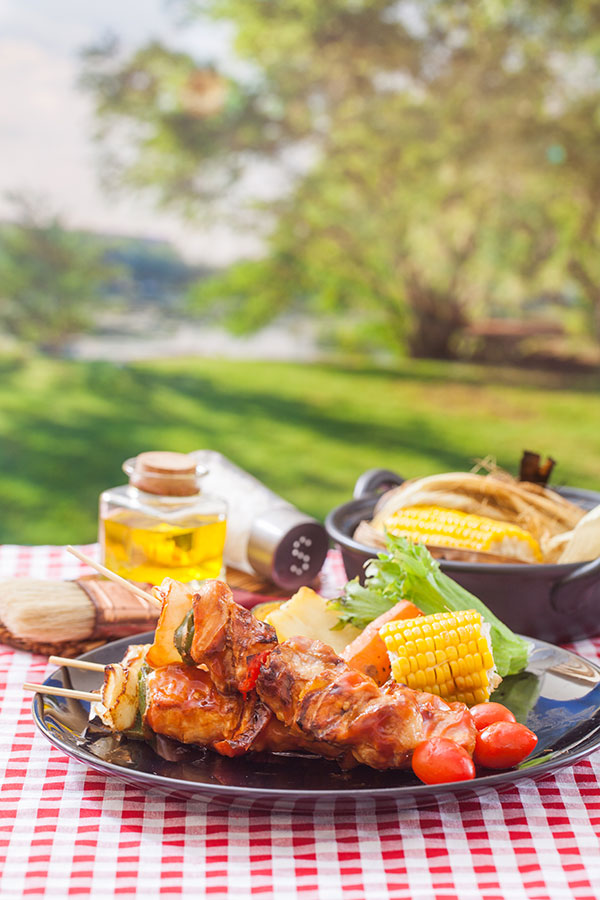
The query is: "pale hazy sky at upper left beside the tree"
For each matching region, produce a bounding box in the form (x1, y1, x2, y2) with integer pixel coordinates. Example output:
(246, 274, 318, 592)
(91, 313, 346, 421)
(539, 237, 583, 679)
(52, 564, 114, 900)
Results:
(0, 0, 259, 264)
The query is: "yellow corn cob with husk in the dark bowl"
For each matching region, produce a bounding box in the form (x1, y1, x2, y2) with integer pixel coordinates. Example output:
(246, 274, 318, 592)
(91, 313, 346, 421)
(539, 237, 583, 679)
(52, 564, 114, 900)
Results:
(384, 506, 542, 562)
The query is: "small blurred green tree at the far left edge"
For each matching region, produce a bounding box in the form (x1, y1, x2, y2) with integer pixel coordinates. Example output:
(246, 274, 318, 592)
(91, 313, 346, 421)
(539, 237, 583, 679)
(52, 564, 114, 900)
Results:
(0, 195, 114, 354)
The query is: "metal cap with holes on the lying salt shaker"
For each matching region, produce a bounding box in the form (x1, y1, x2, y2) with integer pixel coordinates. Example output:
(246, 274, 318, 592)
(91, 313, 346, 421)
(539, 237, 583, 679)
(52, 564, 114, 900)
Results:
(247, 506, 329, 590)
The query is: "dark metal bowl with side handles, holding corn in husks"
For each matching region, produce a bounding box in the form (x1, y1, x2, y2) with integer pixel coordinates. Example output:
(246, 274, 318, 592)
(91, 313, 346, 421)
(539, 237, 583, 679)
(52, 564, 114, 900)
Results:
(325, 469, 600, 643)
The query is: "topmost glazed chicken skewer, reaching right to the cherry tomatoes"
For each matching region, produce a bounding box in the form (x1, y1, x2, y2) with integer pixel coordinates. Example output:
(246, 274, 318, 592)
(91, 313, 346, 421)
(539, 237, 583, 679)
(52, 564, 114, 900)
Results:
(142, 581, 475, 769)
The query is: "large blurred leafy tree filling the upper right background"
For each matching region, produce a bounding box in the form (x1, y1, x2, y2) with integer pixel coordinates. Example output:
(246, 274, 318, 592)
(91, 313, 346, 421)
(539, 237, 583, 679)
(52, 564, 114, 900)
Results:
(82, 0, 600, 357)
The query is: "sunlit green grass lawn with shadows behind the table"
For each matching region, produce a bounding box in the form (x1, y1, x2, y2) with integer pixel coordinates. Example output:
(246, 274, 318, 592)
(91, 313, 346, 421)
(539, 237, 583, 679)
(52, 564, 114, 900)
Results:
(0, 359, 600, 544)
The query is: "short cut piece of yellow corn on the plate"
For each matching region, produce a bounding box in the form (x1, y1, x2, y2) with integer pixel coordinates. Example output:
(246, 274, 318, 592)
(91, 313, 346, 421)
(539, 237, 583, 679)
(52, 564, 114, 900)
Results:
(379, 609, 497, 706)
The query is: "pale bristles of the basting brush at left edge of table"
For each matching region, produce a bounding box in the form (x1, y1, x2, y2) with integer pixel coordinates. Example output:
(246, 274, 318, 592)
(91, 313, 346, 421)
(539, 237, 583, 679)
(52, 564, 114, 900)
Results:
(0, 578, 96, 643)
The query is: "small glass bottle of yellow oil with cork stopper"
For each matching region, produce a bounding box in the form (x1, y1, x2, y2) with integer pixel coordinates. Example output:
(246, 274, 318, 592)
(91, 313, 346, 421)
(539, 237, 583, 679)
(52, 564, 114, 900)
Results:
(99, 451, 226, 584)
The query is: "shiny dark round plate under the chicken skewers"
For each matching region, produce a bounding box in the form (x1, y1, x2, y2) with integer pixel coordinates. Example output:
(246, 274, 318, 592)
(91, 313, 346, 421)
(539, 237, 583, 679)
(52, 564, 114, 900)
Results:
(32, 632, 600, 812)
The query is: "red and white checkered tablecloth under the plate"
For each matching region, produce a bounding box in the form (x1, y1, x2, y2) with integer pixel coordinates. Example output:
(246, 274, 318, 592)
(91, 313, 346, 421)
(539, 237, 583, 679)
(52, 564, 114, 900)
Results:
(0, 546, 600, 900)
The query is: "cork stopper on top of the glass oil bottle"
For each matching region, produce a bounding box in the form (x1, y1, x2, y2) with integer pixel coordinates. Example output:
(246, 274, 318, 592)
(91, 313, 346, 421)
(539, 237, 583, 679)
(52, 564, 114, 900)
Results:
(123, 450, 207, 497)
